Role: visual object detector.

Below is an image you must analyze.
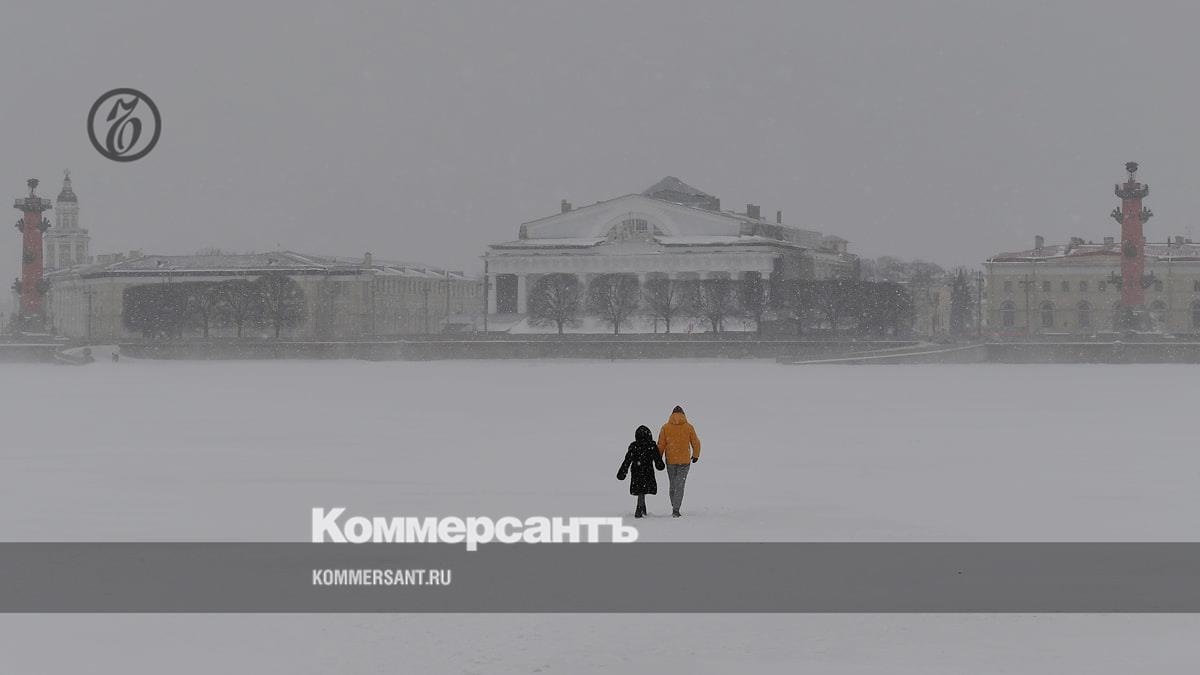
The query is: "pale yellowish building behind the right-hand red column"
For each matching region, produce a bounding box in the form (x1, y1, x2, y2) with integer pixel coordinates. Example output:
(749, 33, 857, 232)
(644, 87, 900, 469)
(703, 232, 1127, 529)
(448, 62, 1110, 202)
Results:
(984, 237, 1200, 336)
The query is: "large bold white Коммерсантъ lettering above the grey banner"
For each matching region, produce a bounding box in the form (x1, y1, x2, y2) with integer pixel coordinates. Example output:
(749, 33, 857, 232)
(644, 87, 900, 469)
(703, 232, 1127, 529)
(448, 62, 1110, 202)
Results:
(312, 507, 637, 551)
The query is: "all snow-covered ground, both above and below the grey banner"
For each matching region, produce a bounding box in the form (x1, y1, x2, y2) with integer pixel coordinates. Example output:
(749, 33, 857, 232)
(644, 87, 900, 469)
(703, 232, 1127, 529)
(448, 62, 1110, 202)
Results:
(0, 360, 1200, 673)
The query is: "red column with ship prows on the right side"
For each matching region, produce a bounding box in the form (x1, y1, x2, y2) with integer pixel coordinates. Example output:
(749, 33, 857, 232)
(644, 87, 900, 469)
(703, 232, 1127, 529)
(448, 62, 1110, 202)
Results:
(1109, 162, 1154, 331)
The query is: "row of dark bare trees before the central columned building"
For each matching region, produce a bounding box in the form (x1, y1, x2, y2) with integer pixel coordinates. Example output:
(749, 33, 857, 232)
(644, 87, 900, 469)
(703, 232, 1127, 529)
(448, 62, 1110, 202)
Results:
(529, 274, 912, 335)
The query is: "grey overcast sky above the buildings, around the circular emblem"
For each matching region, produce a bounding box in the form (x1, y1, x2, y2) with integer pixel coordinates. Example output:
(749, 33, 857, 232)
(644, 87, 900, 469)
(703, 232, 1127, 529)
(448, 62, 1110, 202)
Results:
(0, 0, 1200, 307)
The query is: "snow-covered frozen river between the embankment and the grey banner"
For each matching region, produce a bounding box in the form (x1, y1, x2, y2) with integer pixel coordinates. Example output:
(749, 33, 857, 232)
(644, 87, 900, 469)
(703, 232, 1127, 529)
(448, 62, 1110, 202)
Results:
(0, 360, 1200, 540)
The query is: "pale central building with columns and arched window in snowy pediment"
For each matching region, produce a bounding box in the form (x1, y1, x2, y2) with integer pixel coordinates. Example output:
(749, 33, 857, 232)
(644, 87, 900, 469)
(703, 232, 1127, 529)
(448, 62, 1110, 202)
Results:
(484, 177, 857, 316)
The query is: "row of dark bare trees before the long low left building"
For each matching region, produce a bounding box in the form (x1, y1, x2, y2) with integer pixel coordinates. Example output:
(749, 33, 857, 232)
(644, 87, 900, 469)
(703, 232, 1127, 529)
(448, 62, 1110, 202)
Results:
(121, 273, 307, 339)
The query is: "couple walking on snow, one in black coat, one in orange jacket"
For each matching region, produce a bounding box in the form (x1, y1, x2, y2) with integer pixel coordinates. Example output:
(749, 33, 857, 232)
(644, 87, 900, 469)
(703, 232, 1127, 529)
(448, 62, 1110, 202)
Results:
(617, 406, 700, 518)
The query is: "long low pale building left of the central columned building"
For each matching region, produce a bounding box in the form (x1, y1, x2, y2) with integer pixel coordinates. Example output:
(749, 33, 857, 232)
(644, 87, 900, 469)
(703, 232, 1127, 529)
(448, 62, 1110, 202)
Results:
(47, 251, 482, 341)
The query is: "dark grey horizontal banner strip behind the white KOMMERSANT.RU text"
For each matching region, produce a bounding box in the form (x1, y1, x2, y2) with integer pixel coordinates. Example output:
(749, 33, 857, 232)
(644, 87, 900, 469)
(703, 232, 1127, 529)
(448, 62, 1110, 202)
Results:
(0, 543, 1200, 613)
